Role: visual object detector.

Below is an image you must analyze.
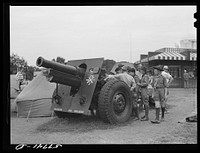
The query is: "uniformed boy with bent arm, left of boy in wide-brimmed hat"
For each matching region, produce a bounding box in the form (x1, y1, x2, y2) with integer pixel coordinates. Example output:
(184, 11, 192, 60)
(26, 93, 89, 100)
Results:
(137, 67, 149, 121)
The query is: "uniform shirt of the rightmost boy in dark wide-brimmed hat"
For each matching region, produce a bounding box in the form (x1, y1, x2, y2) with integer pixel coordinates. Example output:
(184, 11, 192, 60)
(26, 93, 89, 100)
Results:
(153, 74, 168, 88)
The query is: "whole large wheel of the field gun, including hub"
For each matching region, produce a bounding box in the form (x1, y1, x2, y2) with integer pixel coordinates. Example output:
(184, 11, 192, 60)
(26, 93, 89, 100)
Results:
(98, 79, 132, 124)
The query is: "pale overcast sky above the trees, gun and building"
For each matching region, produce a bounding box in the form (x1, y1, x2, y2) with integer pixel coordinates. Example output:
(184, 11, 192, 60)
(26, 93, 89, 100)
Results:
(10, 5, 197, 66)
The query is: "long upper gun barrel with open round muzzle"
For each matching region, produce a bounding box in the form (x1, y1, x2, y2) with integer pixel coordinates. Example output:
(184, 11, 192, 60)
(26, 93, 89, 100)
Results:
(36, 57, 85, 77)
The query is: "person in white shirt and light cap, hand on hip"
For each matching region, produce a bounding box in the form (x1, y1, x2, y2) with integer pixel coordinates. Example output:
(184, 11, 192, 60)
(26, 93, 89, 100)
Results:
(161, 65, 173, 114)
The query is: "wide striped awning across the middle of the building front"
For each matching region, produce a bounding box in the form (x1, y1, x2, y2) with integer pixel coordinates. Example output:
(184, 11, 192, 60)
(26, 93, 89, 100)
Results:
(149, 51, 185, 61)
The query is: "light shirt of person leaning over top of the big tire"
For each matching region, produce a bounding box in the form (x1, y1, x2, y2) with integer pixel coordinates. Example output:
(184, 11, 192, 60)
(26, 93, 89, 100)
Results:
(109, 72, 136, 88)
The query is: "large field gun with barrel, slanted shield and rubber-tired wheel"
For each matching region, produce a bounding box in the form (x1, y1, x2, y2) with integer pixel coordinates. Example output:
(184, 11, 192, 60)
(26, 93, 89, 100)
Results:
(36, 57, 132, 124)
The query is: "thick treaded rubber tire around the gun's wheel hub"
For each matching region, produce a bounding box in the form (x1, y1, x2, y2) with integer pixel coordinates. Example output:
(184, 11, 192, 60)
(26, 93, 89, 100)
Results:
(98, 79, 133, 124)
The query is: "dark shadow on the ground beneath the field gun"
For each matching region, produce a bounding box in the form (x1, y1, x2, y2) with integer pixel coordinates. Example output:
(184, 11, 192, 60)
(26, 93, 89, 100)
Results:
(36, 115, 131, 133)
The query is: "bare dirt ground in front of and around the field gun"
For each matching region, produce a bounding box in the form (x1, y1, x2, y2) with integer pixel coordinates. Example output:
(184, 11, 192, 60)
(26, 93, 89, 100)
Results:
(10, 88, 197, 144)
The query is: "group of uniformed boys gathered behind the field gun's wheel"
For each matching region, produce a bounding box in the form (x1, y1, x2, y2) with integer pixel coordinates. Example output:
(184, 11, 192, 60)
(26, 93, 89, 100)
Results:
(106, 64, 173, 124)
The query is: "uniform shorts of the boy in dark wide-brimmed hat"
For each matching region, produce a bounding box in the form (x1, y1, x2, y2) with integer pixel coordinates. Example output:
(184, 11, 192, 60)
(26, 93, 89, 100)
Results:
(154, 88, 166, 107)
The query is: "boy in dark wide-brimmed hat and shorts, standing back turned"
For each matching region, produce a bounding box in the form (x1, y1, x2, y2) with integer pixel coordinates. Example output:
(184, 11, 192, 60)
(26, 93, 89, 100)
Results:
(151, 65, 168, 124)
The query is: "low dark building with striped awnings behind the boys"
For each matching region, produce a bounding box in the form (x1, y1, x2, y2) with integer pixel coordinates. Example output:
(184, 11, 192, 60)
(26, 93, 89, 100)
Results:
(134, 48, 197, 88)
